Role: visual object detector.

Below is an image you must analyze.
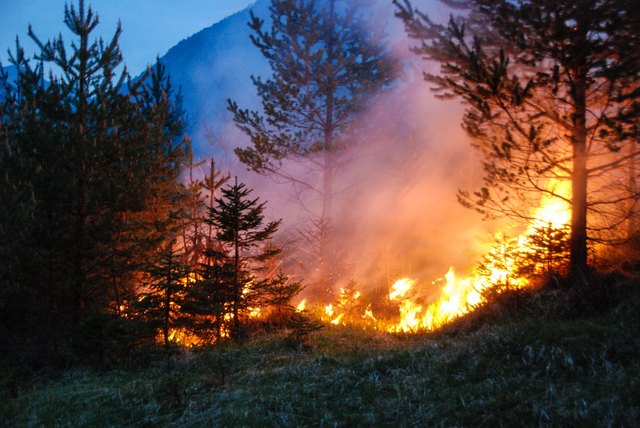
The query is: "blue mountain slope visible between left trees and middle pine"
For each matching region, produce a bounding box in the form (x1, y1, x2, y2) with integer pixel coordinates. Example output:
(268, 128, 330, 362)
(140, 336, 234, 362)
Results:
(160, 0, 270, 162)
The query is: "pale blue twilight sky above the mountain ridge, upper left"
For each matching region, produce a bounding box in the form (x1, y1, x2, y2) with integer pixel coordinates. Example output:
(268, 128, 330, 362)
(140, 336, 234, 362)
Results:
(0, 0, 255, 75)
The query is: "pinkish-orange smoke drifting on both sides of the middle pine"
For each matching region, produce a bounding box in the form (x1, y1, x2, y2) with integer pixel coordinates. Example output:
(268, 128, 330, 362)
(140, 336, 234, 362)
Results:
(188, 0, 487, 294)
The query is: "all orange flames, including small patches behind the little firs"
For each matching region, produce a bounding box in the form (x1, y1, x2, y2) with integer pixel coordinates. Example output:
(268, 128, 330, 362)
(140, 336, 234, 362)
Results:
(150, 174, 570, 348)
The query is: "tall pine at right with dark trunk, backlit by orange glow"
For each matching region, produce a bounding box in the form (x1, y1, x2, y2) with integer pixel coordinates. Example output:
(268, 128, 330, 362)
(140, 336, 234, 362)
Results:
(394, 0, 640, 283)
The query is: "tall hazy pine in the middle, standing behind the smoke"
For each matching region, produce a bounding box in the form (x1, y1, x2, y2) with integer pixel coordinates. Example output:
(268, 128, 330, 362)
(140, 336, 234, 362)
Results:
(229, 0, 395, 291)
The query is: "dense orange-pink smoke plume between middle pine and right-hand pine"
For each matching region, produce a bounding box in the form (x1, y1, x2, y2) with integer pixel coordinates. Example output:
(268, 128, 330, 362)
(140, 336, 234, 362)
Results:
(335, 61, 485, 285)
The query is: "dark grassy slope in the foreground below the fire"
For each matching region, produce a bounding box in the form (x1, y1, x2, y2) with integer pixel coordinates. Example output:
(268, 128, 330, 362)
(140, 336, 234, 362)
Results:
(5, 293, 640, 427)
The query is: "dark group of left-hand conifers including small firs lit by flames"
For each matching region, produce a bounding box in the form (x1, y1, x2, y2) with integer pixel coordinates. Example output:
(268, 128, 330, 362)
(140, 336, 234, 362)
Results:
(0, 0, 301, 364)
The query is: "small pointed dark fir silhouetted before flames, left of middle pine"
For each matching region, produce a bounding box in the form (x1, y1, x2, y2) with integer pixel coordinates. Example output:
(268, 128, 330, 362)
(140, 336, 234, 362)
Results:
(203, 179, 281, 339)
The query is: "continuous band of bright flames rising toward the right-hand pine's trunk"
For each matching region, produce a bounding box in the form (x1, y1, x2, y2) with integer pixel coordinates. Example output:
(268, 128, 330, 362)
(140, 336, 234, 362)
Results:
(308, 182, 570, 333)
